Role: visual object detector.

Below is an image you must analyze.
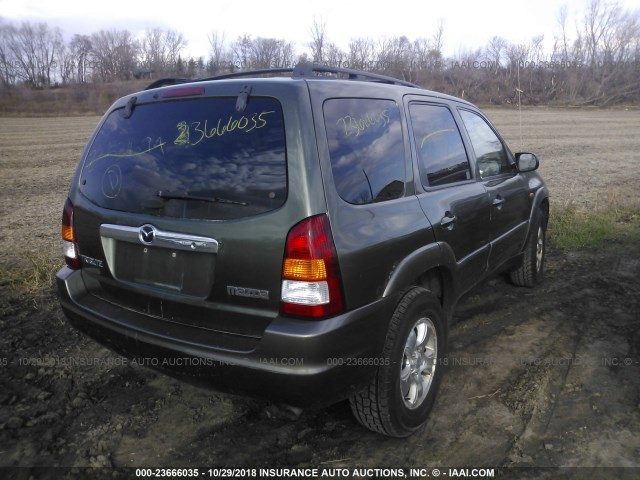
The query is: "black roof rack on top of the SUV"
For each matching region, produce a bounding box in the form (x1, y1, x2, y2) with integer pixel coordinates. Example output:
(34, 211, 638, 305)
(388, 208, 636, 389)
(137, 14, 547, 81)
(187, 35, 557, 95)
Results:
(145, 63, 421, 90)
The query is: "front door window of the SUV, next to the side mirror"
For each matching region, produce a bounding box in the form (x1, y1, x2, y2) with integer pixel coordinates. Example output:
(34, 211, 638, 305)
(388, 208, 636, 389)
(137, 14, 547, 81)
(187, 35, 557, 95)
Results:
(460, 110, 511, 178)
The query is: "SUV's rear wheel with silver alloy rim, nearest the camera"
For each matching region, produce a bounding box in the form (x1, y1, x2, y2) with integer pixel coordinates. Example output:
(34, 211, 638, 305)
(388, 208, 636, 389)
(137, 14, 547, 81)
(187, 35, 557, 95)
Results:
(350, 287, 446, 437)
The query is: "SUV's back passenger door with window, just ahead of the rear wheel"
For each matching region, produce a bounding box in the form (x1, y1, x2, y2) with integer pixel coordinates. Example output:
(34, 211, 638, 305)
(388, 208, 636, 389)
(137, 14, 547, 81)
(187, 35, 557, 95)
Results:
(408, 99, 491, 290)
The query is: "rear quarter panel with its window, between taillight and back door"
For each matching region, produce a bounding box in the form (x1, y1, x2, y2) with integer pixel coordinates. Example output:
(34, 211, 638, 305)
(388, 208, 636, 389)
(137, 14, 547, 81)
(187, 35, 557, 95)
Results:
(313, 94, 433, 308)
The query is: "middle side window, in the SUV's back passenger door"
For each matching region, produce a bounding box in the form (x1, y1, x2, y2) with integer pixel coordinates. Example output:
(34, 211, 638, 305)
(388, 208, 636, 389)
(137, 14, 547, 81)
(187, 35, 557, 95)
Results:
(409, 103, 471, 187)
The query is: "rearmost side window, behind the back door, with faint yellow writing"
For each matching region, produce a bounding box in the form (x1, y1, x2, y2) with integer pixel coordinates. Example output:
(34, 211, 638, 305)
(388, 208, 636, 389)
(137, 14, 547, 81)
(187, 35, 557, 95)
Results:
(324, 98, 405, 205)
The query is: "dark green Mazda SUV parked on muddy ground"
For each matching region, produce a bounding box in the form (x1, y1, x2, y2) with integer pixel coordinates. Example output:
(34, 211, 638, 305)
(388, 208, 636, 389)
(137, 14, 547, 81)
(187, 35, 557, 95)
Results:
(57, 65, 549, 437)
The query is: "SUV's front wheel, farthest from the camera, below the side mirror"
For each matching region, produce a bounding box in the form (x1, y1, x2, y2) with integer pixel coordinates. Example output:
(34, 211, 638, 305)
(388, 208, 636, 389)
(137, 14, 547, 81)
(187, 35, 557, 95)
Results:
(510, 209, 547, 287)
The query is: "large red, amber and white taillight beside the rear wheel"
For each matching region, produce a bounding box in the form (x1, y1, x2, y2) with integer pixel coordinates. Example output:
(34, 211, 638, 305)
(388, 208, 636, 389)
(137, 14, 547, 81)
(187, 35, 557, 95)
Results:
(280, 215, 344, 318)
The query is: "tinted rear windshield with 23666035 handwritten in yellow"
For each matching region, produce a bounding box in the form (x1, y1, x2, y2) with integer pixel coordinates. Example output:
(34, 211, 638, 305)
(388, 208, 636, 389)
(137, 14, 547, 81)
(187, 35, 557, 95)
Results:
(80, 97, 287, 220)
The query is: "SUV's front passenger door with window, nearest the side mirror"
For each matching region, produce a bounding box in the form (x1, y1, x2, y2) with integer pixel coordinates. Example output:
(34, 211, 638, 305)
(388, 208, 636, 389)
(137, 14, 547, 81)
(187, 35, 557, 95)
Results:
(459, 109, 531, 270)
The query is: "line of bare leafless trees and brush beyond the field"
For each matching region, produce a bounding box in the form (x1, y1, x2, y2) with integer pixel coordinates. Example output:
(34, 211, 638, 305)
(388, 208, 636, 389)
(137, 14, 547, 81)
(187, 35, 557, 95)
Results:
(0, 0, 640, 105)
